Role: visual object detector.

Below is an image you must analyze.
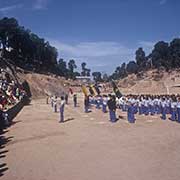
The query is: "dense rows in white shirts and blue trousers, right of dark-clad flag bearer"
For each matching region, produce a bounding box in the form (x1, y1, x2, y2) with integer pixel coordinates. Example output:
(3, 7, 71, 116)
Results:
(118, 95, 180, 122)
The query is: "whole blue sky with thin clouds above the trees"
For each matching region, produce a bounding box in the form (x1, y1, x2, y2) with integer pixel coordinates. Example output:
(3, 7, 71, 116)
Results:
(0, 0, 180, 73)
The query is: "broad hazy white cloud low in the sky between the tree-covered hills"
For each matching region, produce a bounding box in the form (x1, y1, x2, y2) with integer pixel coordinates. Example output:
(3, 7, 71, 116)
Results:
(48, 39, 135, 73)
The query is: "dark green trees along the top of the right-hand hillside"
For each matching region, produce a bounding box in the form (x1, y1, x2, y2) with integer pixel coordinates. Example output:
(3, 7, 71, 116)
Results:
(110, 38, 180, 79)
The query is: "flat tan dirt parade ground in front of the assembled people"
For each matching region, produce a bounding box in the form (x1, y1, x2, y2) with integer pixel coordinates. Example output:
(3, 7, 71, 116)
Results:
(0, 94, 180, 180)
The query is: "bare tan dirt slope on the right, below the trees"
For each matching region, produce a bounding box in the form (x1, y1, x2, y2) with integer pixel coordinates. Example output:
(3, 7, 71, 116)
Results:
(118, 70, 180, 94)
